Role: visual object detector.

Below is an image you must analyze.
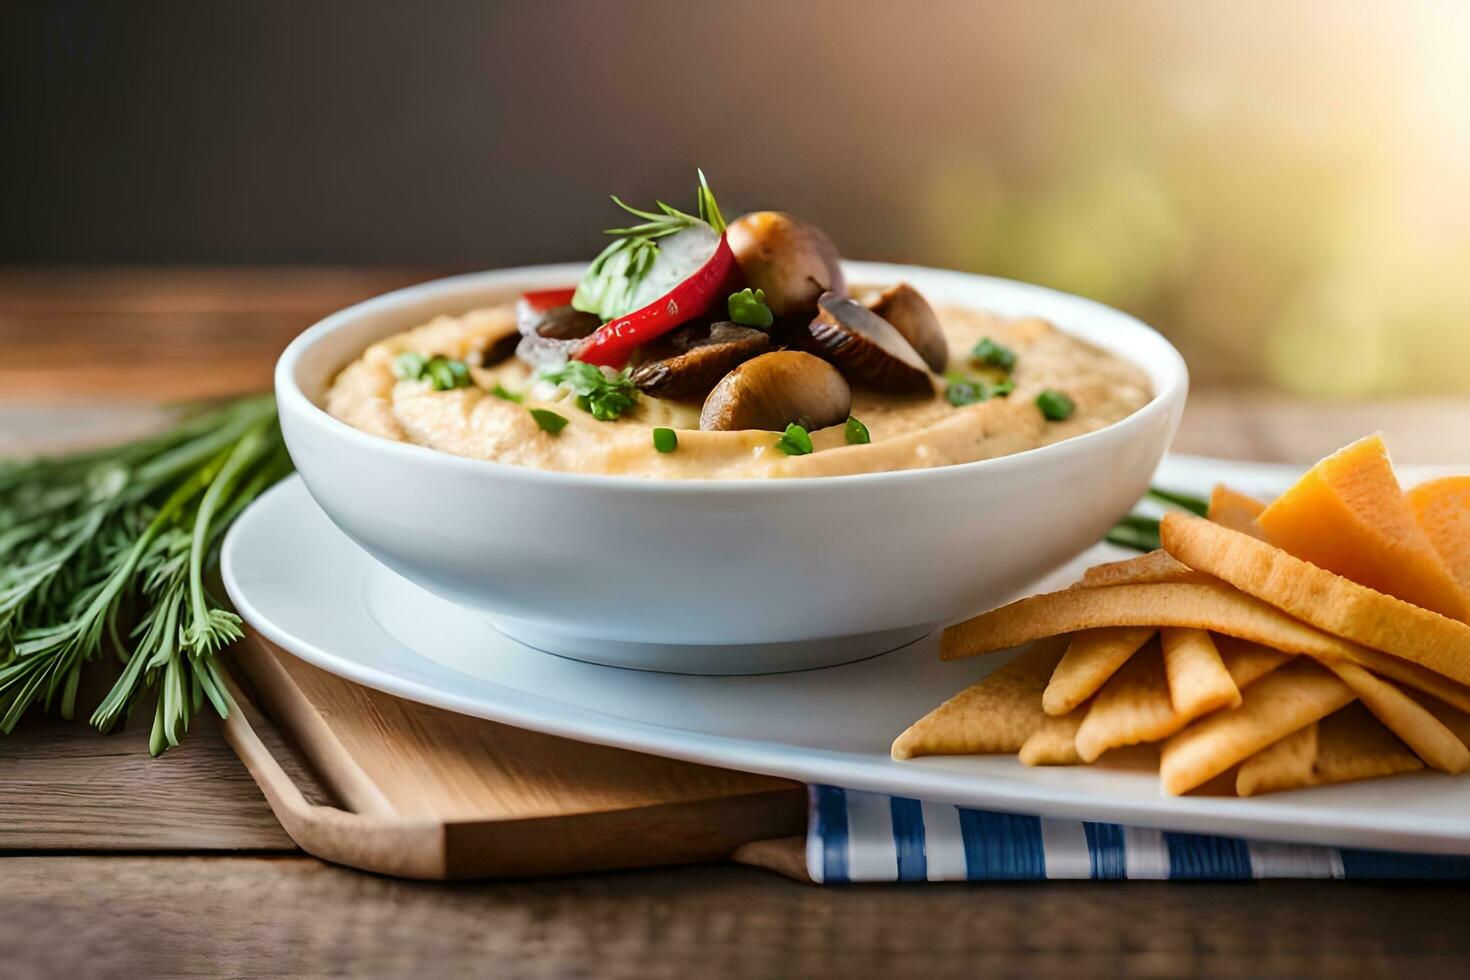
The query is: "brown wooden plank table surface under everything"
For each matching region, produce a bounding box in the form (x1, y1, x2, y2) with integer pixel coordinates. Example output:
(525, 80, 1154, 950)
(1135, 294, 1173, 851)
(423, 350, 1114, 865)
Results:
(0, 267, 1470, 977)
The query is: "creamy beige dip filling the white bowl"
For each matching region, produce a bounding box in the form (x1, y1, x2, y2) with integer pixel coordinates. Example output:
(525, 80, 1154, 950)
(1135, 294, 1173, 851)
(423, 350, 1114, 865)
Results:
(326, 304, 1152, 479)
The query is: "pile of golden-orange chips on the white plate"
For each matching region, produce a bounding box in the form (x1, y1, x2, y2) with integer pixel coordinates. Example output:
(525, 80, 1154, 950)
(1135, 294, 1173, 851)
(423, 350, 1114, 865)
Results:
(892, 436, 1470, 796)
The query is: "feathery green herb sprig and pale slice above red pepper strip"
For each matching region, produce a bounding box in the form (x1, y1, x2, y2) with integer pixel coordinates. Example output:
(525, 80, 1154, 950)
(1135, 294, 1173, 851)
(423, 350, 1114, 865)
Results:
(572, 170, 725, 320)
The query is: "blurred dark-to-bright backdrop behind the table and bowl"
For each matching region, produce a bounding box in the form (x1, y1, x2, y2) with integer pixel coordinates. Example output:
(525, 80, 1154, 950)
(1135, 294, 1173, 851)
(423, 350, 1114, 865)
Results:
(0, 0, 1470, 397)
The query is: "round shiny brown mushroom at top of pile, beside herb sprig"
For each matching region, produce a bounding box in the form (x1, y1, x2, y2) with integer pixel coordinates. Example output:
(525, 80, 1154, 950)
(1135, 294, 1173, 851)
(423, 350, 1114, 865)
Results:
(725, 212, 847, 320)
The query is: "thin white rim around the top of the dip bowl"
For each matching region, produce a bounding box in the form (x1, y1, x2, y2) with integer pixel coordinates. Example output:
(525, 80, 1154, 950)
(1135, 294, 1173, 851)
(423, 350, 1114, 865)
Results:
(275, 260, 1189, 497)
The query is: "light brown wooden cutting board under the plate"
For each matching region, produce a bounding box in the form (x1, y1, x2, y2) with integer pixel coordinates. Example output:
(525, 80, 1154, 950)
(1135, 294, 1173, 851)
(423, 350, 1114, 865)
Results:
(222, 633, 806, 879)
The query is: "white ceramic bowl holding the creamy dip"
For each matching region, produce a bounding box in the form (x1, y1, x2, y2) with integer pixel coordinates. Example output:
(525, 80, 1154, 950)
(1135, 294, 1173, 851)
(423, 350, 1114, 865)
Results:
(275, 263, 1188, 673)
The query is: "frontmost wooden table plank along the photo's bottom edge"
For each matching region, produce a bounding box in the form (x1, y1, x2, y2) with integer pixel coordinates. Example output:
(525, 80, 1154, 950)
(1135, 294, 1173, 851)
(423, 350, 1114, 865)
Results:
(0, 857, 1470, 979)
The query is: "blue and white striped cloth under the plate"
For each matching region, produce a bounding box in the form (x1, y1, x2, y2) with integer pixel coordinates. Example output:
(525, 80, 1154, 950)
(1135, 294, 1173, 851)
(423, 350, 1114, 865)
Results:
(807, 786, 1470, 883)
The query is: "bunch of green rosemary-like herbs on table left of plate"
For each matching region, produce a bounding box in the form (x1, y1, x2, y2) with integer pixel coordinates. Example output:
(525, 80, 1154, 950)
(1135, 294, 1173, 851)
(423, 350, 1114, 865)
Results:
(0, 397, 291, 755)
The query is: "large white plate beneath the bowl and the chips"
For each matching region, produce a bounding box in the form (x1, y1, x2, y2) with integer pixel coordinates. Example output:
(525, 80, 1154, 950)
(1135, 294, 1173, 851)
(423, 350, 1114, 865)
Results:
(222, 457, 1470, 854)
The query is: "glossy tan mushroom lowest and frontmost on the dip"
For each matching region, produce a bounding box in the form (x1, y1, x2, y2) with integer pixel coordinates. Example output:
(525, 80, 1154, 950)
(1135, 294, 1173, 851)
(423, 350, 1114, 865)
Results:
(700, 351, 853, 432)
